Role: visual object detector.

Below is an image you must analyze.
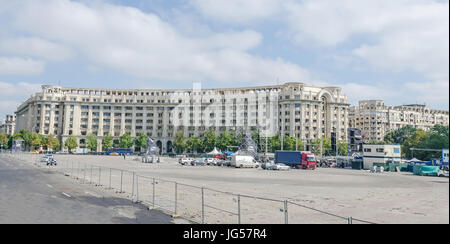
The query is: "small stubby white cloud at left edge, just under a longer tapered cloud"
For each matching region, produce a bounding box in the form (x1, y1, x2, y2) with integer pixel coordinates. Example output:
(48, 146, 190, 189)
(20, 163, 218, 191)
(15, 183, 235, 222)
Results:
(0, 57, 45, 75)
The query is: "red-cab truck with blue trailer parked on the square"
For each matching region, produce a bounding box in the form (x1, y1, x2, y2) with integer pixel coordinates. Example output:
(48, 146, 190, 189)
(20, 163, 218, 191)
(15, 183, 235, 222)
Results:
(275, 151, 317, 170)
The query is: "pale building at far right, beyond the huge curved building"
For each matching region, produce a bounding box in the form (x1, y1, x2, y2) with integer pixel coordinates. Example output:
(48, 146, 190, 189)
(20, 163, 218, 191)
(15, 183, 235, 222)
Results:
(349, 100, 449, 143)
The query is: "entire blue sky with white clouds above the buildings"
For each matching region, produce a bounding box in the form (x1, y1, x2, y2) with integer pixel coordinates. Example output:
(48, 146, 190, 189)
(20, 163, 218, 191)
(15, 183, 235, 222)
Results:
(0, 0, 449, 119)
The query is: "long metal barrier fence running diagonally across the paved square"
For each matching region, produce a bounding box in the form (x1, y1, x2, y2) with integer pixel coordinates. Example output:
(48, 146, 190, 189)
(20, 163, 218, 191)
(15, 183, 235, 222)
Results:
(1, 154, 375, 224)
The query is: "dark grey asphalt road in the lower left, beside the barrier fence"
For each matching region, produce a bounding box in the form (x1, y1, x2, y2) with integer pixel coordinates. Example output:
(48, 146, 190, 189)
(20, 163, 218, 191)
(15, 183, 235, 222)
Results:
(0, 156, 172, 224)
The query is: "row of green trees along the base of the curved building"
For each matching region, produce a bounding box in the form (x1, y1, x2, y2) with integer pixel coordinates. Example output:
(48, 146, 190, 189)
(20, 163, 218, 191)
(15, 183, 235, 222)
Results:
(0, 130, 347, 155)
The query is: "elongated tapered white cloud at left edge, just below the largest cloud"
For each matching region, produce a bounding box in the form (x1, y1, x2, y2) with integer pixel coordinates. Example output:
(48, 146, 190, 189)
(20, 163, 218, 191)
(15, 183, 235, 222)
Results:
(0, 37, 73, 61)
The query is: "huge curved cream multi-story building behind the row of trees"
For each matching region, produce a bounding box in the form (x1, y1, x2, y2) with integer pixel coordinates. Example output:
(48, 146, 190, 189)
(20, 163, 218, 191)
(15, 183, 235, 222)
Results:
(16, 83, 349, 152)
